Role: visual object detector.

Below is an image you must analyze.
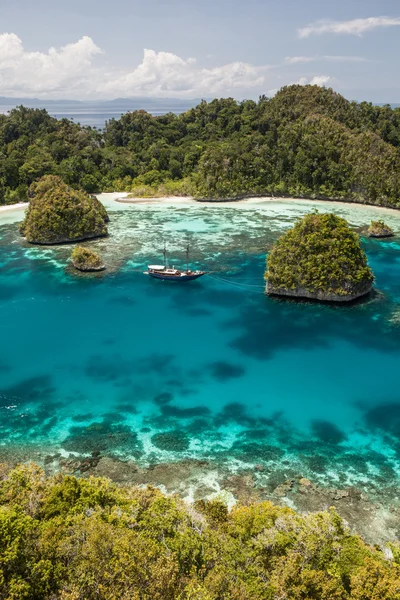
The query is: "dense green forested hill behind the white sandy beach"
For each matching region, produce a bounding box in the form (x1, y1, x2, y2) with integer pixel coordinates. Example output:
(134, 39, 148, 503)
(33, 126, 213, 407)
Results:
(0, 85, 400, 208)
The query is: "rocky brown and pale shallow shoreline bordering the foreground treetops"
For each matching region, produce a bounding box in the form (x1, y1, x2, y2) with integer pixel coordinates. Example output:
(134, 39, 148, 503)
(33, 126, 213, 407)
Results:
(0, 444, 399, 544)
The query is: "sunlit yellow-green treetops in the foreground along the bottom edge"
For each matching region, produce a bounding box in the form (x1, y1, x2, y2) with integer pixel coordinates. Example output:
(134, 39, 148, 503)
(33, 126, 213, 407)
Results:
(0, 465, 400, 600)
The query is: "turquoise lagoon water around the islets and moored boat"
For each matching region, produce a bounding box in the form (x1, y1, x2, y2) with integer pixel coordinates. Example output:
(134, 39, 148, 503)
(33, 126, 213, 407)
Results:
(0, 195, 400, 496)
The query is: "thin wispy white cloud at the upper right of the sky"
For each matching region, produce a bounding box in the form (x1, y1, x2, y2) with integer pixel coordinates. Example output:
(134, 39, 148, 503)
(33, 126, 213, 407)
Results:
(298, 17, 400, 38)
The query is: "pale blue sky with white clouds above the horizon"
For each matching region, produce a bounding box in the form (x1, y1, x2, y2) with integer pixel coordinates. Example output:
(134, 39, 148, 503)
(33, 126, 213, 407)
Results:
(0, 0, 400, 103)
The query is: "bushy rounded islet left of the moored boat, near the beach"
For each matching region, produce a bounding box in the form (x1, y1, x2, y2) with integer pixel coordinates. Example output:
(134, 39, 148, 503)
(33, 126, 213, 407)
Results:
(20, 175, 109, 244)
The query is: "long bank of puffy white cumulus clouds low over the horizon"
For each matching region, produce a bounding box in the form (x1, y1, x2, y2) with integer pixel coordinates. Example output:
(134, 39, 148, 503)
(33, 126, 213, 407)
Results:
(0, 33, 268, 98)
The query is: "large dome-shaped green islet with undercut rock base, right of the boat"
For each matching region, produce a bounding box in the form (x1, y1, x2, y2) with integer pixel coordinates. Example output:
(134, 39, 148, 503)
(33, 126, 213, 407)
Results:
(265, 212, 374, 302)
